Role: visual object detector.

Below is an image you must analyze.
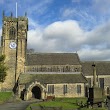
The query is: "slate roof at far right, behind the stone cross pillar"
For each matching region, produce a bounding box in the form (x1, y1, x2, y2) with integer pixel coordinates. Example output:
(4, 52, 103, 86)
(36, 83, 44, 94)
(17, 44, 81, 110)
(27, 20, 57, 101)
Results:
(81, 61, 110, 76)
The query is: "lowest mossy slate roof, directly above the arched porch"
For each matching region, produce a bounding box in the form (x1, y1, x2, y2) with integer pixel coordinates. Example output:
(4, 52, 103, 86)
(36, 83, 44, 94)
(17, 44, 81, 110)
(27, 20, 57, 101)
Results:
(18, 73, 87, 84)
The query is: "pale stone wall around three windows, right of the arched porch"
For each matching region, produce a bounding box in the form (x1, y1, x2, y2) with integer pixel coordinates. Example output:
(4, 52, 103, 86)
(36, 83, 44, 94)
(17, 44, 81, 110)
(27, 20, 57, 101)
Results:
(47, 83, 85, 97)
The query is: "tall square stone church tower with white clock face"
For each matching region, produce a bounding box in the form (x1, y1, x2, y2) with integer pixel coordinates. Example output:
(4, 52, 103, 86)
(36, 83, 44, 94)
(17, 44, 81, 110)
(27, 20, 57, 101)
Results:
(1, 12, 28, 89)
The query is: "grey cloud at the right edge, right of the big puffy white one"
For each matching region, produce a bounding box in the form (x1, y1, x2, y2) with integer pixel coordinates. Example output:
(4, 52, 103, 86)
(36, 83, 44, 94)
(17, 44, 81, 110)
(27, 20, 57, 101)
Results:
(85, 22, 110, 46)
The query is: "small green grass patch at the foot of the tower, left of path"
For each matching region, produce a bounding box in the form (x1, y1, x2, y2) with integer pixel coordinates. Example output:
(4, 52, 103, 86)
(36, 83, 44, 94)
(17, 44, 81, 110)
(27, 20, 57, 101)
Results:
(0, 92, 12, 103)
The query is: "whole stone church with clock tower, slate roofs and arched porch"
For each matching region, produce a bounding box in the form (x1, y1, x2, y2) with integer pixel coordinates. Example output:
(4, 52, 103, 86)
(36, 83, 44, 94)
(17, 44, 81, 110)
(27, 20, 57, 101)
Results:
(0, 13, 110, 100)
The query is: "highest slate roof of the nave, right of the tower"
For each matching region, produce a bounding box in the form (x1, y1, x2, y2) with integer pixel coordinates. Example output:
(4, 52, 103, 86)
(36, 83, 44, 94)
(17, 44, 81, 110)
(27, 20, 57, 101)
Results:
(26, 53, 80, 66)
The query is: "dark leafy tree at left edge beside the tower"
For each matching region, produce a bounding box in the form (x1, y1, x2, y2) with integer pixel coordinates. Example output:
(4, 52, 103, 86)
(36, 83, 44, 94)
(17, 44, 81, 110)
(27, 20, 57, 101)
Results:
(0, 55, 7, 82)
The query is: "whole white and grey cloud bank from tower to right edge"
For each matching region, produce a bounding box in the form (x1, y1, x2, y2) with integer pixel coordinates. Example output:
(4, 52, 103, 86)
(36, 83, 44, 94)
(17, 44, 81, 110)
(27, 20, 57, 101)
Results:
(28, 20, 110, 60)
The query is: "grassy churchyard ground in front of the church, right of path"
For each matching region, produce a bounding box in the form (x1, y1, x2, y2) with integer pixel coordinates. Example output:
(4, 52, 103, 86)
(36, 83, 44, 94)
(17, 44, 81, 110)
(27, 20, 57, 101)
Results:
(26, 98, 107, 110)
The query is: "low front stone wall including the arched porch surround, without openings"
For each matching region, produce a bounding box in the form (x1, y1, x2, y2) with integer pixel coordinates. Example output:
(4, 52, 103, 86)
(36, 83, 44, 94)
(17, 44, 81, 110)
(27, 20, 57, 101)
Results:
(18, 82, 85, 100)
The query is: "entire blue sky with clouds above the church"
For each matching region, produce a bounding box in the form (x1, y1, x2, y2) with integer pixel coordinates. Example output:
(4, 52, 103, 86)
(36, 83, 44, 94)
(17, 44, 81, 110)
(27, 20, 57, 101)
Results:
(0, 0, 110, 61)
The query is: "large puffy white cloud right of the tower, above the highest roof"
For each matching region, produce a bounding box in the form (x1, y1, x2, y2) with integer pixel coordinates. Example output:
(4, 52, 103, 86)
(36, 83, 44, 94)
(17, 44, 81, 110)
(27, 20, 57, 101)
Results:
(28, 20, 85, 52)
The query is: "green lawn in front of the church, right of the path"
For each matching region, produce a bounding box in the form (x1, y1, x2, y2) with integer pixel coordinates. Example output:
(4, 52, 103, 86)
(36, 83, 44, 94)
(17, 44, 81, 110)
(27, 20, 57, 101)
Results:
(26, 98, 106, 110)
